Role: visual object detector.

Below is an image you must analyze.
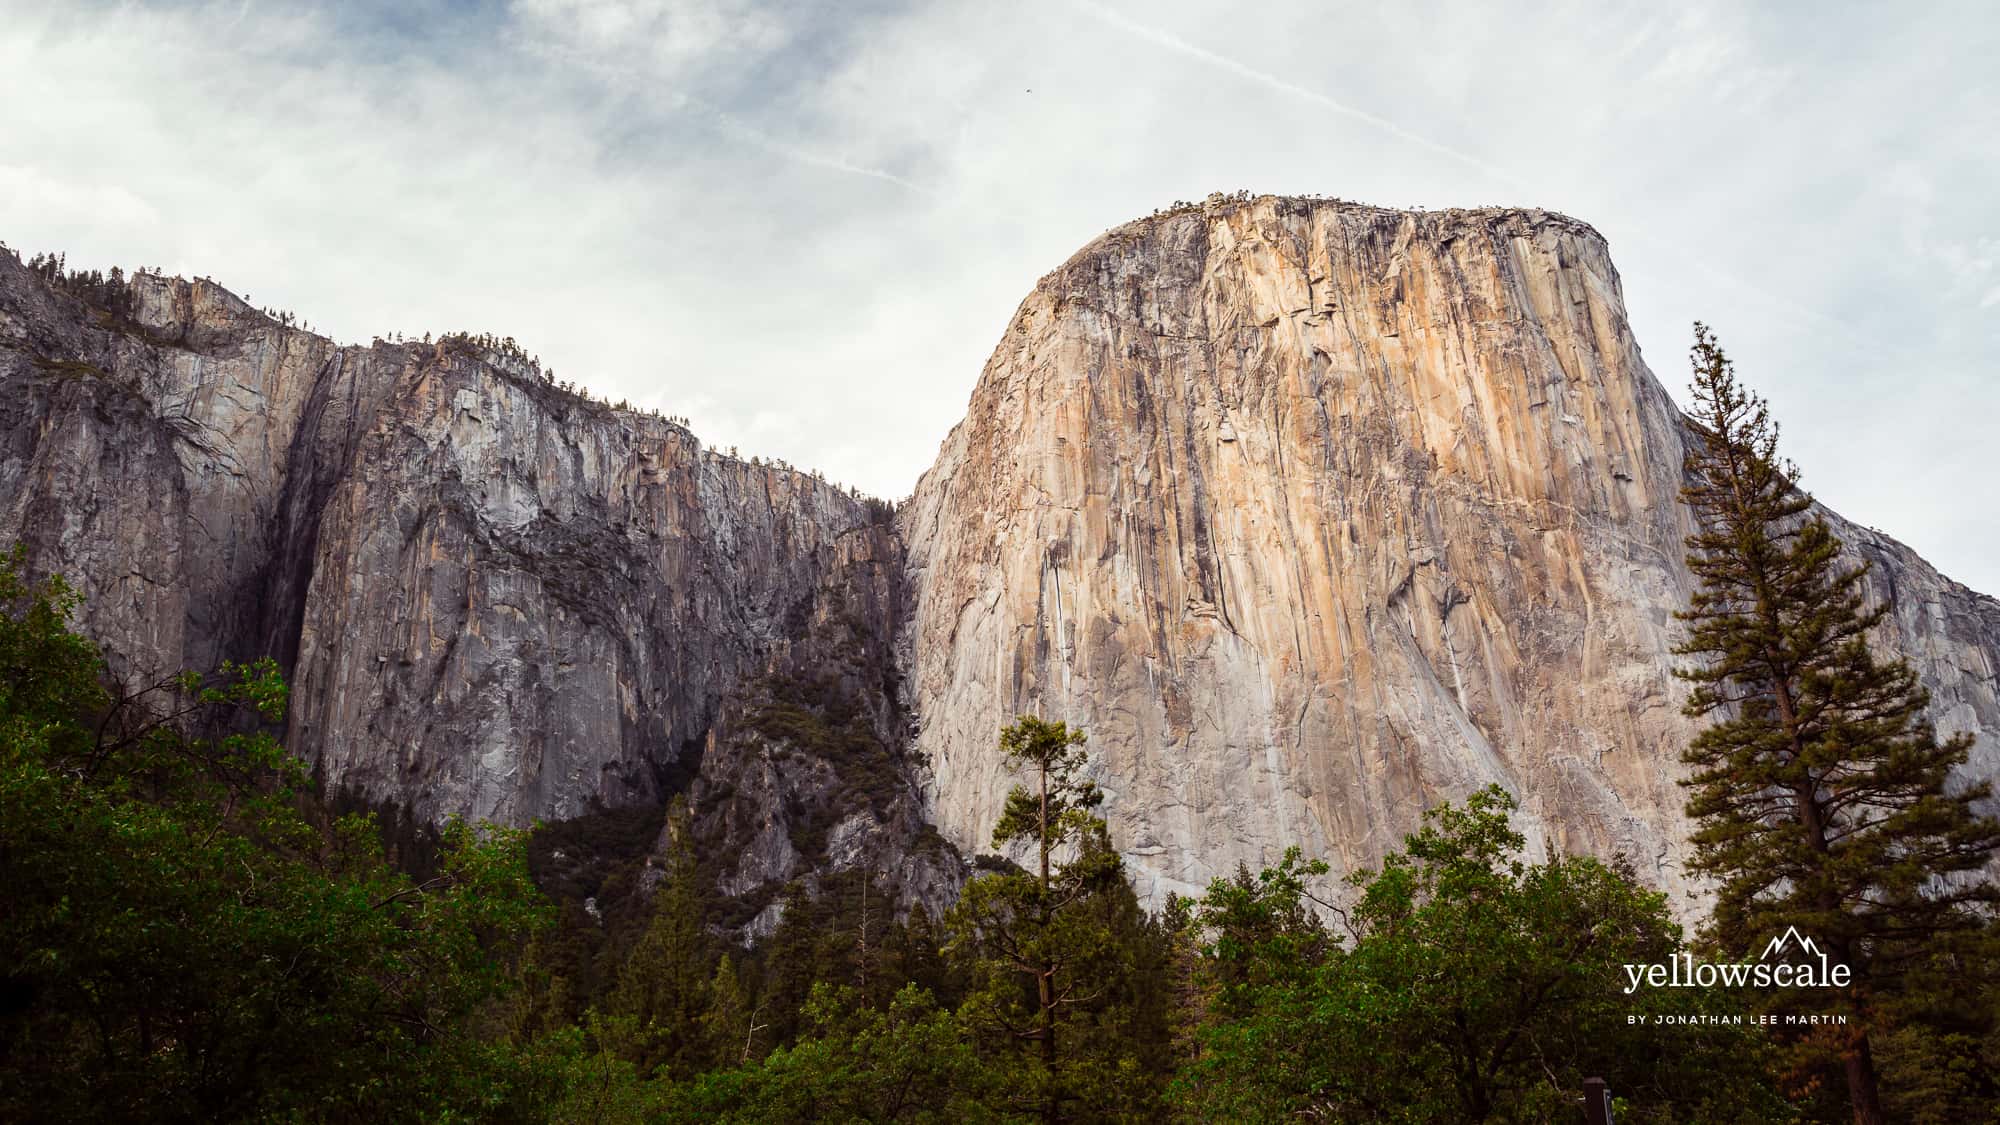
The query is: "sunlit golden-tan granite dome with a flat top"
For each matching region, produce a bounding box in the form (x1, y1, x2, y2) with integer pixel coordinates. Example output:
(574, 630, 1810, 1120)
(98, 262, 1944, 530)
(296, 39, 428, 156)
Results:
(900, 198, 2000, 893)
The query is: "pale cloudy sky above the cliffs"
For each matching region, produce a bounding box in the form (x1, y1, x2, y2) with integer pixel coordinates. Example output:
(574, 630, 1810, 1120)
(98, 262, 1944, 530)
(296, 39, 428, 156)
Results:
(0, 0, 2000, 593)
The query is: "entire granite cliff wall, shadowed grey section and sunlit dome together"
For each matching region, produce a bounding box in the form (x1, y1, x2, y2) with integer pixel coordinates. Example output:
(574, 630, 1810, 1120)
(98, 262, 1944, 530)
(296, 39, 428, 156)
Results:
(0, 196, 2000, 916)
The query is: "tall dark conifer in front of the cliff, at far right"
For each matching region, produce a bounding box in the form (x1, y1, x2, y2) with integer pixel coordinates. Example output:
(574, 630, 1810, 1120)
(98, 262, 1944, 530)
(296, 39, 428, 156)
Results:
(1676, 324, 2000, 1123)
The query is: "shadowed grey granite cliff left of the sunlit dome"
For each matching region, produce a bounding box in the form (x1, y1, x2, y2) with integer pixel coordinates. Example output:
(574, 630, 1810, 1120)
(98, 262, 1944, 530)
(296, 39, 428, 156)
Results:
(0, 252, 958, 916)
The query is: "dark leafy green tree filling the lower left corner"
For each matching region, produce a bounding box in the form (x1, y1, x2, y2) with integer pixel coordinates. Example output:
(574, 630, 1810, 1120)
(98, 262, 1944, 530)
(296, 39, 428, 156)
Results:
(0, 552, 544, 1121)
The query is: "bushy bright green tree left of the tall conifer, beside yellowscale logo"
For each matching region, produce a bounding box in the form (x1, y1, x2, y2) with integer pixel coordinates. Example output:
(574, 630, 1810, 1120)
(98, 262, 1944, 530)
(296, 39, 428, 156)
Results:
(1174, 789, 1786, 1123)
